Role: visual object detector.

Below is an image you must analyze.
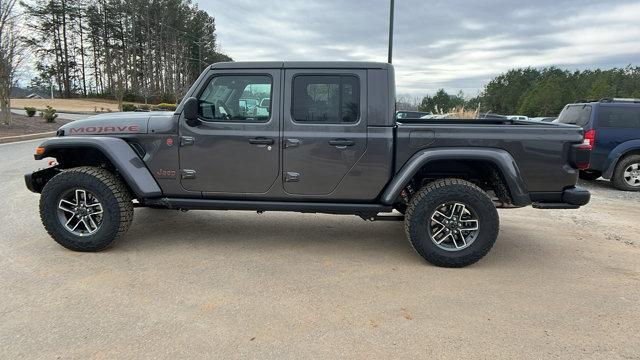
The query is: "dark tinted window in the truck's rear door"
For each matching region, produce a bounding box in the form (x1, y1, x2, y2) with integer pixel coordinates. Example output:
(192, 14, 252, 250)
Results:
(292, 75, 360, 124)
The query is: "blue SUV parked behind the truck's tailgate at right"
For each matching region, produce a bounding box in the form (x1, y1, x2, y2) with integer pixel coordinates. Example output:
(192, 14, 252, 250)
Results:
(557, 99, 640, 191)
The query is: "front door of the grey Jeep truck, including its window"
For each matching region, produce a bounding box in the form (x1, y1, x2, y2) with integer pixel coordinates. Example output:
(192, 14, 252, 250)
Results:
(180, 69, 281, 196)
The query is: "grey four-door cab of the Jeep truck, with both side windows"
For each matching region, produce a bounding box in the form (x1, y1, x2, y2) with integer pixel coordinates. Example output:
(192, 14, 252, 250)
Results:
(178, 62, 394, 202)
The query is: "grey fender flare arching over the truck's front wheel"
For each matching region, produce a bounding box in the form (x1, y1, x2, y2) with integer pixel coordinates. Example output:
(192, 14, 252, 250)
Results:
(34, 136, 162, 198)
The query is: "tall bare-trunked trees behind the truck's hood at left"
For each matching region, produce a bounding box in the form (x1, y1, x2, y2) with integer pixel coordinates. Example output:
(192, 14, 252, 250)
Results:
(21, 0, 231, 103)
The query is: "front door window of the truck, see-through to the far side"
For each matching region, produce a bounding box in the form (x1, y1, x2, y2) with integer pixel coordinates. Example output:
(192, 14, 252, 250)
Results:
(198, 75, 271, 122)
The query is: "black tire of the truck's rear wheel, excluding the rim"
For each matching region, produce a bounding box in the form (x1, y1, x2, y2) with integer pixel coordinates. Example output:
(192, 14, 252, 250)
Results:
(404, 178, 500, 268)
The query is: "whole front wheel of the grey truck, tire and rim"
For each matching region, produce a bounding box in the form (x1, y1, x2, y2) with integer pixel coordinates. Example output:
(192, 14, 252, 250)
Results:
(40, 166, 133, 251)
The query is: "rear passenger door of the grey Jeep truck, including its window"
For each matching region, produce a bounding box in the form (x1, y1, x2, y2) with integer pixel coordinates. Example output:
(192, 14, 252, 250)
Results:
(282, 69, 367, 195)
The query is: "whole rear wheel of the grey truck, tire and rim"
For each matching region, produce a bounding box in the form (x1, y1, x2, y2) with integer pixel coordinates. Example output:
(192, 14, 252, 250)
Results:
(405, 179, 500, 267)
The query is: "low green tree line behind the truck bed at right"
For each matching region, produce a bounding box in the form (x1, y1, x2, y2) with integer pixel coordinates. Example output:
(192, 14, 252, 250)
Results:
(410, 66, 640, 116)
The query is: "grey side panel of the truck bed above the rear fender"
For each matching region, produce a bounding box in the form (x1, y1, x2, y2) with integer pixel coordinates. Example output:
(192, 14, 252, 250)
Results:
(395, 119, 583, 195)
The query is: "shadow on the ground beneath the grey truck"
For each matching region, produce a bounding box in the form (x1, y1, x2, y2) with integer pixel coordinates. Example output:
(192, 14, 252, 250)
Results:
(113, 208, 526, 266)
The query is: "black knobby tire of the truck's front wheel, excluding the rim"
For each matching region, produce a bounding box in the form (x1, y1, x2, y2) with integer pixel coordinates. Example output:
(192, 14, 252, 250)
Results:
(40, 166, 133, 252)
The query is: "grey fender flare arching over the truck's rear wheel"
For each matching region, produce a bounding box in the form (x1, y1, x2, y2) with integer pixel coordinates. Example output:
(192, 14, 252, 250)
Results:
(381, 147, 531, 206)
